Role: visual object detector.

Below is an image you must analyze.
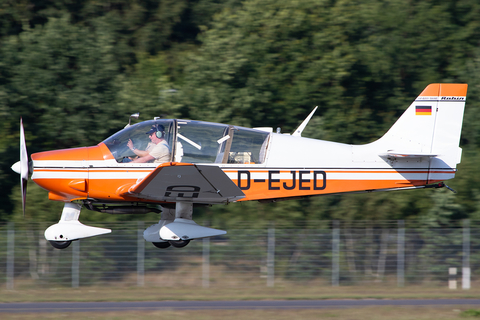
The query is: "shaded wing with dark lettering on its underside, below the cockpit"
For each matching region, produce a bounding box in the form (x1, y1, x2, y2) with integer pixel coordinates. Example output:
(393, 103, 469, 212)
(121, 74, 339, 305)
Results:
(125, 163, 245, 204)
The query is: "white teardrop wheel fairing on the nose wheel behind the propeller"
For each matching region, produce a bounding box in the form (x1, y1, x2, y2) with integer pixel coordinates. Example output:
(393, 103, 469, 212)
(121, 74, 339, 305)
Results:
(45, 220, 112, 241)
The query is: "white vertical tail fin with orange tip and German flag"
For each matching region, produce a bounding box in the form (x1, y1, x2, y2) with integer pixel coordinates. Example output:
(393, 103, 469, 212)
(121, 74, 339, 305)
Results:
(377, 83, 467, 168)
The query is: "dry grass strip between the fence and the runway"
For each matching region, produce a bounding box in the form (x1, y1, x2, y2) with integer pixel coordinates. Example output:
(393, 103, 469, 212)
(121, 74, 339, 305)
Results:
(0, 281, 480, 302)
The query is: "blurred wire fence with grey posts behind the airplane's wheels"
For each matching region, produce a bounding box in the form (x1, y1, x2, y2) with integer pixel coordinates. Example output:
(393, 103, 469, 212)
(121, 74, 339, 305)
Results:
(0, 220, 480, 289)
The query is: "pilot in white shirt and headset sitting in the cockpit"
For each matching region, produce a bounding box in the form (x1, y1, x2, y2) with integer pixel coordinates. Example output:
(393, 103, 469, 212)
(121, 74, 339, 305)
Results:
(127, 124, 170, 163)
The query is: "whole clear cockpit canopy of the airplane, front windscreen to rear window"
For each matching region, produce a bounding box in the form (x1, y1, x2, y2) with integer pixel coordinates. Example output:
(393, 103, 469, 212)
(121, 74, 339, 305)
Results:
(103, 119, 269, 164)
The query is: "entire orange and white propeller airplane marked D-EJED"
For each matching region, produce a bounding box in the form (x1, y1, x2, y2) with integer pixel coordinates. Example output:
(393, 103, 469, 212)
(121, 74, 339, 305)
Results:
(12, 84, 467, 249)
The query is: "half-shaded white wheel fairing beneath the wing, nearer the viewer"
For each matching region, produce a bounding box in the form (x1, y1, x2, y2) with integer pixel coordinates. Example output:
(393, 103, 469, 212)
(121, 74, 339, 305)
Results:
(160, 218, 227, 240)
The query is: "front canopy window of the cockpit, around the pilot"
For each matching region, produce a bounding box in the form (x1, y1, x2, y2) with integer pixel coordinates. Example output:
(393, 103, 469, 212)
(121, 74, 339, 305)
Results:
(103, 120, 175, 162)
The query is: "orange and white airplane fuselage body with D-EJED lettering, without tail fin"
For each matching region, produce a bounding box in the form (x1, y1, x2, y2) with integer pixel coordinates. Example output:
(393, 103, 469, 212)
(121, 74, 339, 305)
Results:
(32, 120, 455, 203)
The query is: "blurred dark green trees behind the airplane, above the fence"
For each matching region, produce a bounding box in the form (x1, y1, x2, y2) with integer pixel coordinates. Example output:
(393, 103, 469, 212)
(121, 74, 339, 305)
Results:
(0, 0, 480, 225)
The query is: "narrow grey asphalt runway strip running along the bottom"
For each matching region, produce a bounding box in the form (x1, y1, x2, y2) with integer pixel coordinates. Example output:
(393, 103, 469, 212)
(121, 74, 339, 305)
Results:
(0, 299, 480, 313)
